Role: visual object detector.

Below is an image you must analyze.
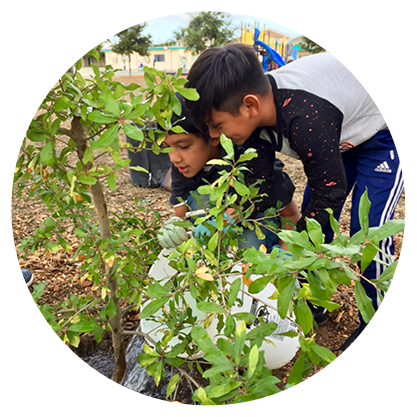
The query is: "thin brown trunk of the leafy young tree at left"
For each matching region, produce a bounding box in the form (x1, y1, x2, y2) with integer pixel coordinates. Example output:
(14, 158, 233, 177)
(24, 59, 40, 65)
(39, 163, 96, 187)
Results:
(71, 116, 127, 384)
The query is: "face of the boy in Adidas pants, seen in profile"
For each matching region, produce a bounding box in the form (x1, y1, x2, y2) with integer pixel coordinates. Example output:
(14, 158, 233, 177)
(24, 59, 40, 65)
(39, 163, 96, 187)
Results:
(207, 105, 258, 145)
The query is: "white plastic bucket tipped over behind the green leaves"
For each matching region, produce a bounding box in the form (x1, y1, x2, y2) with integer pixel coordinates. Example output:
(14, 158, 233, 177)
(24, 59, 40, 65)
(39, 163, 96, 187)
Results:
(141, 249, 300, 369)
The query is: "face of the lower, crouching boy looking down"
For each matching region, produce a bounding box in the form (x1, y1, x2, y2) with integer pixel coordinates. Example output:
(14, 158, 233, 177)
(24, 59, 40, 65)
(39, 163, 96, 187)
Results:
(164, 133, 220, 178)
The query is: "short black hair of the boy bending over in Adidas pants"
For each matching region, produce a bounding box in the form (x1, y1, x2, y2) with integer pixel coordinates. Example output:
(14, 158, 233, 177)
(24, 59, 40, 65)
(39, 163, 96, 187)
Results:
(185, 43, 270, 123)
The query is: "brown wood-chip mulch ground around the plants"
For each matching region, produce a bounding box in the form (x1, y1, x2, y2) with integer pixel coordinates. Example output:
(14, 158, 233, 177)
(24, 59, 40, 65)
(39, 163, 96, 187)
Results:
(11, 77, 406, 394)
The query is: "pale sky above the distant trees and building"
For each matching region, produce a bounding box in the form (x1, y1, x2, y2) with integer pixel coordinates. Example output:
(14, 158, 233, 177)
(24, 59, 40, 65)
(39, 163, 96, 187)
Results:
(132, 13, 300, 44)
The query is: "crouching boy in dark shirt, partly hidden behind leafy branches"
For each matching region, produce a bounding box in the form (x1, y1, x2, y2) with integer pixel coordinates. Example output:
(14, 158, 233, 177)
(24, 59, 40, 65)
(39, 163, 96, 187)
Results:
(159, 93, 301, 251)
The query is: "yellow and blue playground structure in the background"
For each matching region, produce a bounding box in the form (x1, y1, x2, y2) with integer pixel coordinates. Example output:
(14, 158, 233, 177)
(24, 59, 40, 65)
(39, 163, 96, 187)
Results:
(241, 22, 292, 72)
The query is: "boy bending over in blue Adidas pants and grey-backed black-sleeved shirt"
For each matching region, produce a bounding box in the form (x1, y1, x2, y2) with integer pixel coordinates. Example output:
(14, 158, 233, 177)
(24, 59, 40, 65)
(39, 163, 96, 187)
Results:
(186, 44, 404, 348)
